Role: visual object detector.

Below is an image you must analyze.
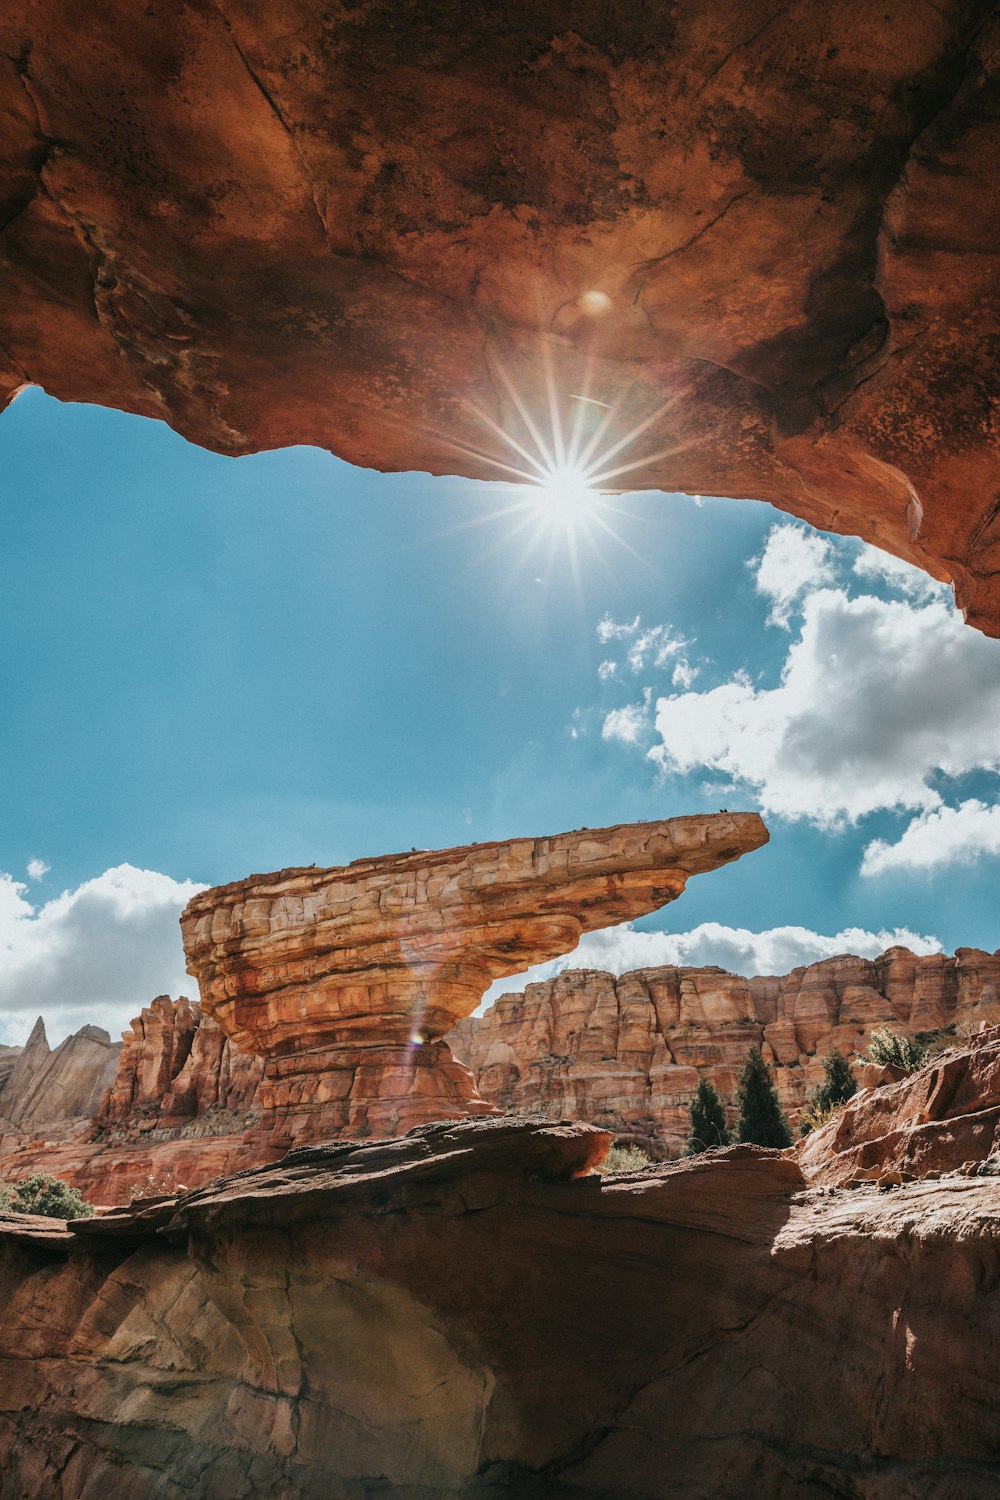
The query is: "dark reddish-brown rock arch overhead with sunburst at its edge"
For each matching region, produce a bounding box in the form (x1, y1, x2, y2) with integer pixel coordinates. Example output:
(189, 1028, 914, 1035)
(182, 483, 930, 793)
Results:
(0, 0, 1000, 635)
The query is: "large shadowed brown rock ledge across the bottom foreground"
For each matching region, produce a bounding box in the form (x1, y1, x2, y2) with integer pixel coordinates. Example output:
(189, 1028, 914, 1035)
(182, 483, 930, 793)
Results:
(0, 1121, 1000, 1500)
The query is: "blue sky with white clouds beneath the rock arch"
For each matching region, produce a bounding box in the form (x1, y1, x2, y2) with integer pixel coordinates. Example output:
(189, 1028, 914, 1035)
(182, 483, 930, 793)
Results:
(0, 390, 1000, 1041)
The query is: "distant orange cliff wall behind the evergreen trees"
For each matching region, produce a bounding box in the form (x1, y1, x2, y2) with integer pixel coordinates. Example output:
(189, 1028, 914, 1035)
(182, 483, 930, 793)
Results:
(448, 948, 1000, 1157)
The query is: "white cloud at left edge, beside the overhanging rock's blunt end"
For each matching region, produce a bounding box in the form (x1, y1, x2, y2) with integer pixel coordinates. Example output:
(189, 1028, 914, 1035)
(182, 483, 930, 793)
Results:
(0, 864, 204, 1043)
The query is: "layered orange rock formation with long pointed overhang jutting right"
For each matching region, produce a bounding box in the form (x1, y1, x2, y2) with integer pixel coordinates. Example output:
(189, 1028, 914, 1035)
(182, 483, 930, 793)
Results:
(181, 813, 768, 1145)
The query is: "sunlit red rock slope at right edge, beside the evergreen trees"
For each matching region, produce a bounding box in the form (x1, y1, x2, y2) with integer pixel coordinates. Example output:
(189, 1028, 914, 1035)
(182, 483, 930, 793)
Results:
(799, 1026, 1000, 1184)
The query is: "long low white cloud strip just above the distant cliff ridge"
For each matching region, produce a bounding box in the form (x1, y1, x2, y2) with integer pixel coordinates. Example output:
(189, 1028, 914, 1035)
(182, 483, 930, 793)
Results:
(483, 923, 942, 1007)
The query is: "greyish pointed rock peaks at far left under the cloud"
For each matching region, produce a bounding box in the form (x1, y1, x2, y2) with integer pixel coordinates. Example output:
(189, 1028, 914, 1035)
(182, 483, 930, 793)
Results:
(0, 1017, 120, 1149)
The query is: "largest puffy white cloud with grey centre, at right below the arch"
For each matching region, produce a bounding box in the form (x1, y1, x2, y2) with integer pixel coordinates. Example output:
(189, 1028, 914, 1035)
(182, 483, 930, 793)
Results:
(649, 590, 1000, 827)
